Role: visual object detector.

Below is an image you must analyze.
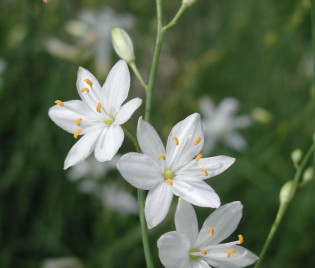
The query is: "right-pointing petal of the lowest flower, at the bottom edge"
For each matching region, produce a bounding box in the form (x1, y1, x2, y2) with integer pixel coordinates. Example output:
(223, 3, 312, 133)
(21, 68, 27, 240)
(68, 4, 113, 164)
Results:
(205, 245, 258, 268)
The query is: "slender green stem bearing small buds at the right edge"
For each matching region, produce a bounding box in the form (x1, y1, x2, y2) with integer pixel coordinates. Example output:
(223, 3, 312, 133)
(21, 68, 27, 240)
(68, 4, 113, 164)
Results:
(254, 143, 315, 268)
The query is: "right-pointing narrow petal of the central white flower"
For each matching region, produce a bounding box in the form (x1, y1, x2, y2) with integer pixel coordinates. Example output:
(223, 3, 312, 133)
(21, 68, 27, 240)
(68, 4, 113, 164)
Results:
(176, 155, 235, 180)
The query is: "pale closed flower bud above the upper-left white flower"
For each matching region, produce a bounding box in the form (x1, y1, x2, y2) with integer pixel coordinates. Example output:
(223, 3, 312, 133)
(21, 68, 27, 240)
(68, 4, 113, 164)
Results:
(112, 27, 135, 63)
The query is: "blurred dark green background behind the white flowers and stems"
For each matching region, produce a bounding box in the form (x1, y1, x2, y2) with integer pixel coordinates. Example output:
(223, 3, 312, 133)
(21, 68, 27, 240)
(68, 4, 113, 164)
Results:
(0, 0, 315, 268)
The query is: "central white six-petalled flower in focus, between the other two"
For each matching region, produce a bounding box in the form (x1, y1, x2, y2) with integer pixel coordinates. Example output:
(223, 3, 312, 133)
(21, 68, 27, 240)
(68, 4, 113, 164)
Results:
(117, 113, 235, 228)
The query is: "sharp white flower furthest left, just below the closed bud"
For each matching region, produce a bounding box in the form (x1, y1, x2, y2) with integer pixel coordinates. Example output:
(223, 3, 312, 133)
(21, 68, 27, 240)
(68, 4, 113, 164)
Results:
(49, 60, 142, 169)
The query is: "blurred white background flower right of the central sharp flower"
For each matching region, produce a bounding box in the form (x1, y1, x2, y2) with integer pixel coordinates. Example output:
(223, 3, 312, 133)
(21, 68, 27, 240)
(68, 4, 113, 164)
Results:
(199, 97, 252, 152)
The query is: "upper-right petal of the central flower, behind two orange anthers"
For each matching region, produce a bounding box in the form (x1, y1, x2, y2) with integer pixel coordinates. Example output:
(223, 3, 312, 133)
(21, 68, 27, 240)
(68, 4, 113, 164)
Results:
(166, 113, 204, 170)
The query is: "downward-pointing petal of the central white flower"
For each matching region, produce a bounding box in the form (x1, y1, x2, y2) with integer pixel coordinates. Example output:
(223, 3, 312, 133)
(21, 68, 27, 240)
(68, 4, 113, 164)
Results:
(144, 181, 173, 229)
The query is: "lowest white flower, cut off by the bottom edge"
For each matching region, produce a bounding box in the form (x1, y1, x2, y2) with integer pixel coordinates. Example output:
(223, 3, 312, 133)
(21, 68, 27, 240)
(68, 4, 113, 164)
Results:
(157, 199, 258, 268)
